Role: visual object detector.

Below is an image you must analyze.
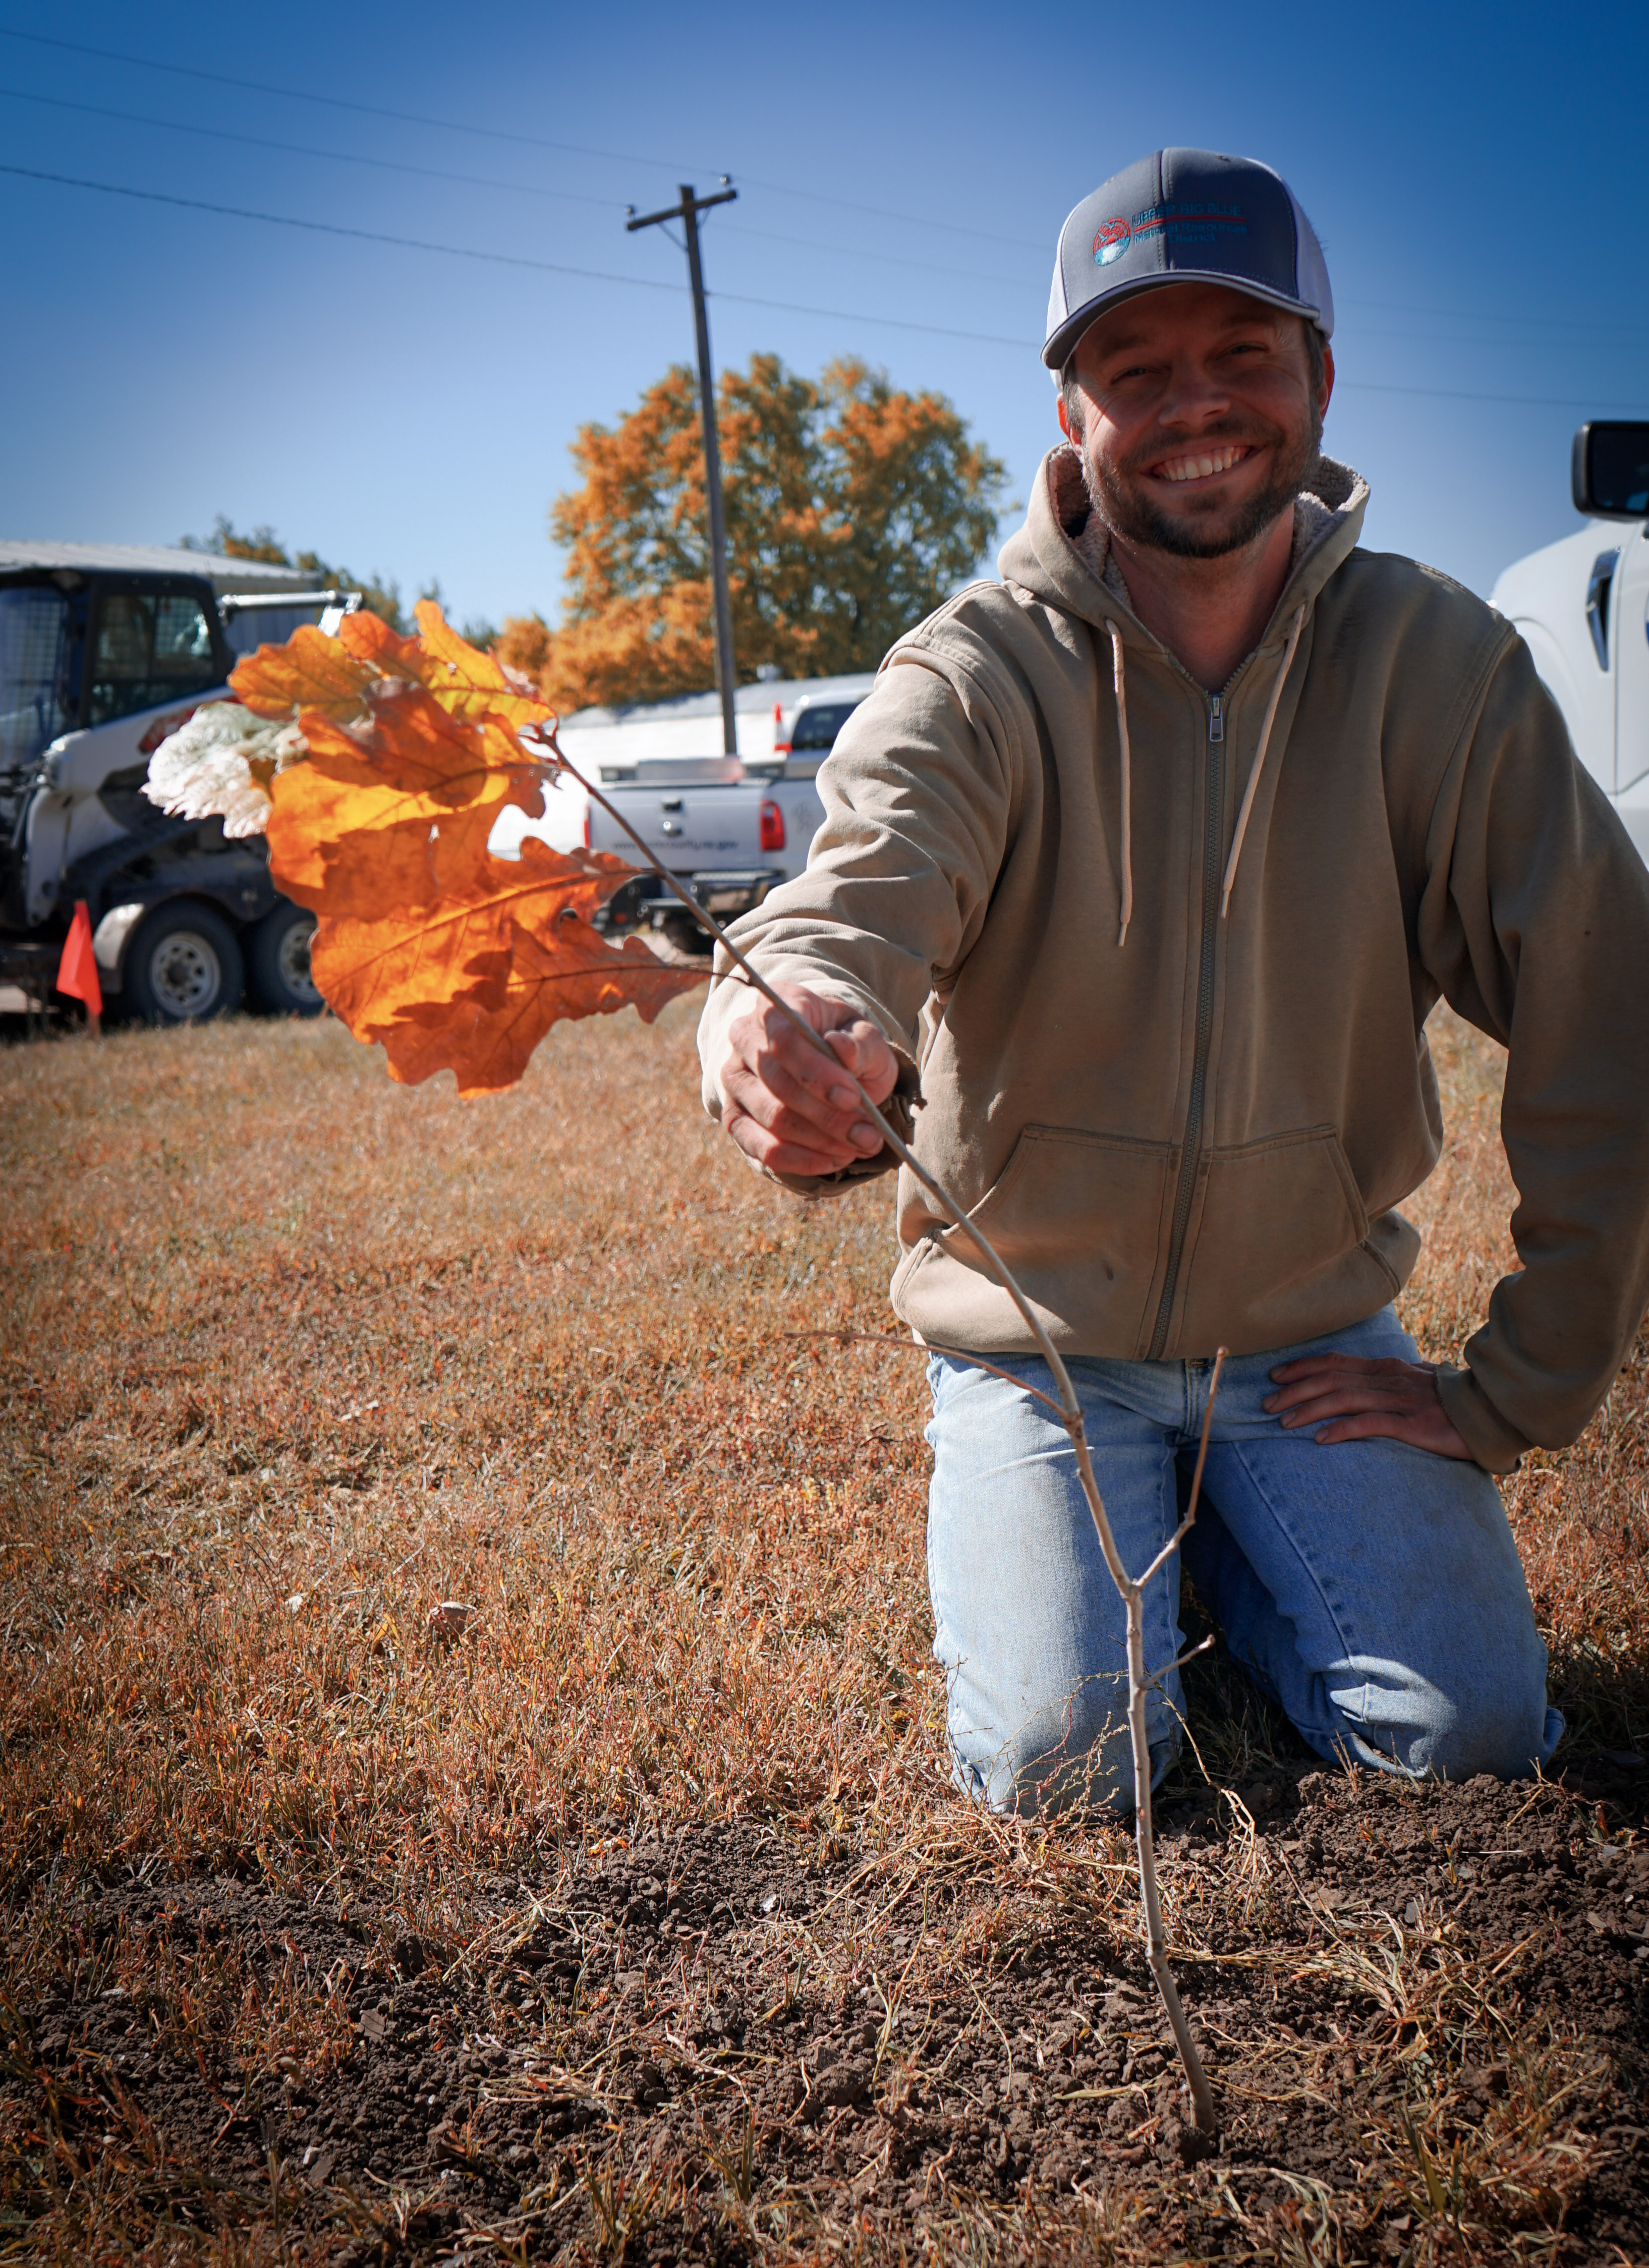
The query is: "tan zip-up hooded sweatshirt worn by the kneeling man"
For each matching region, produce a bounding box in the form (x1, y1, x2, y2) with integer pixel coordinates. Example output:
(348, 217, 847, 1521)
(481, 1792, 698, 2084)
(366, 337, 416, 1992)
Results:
(699, 449, 1649, 1472)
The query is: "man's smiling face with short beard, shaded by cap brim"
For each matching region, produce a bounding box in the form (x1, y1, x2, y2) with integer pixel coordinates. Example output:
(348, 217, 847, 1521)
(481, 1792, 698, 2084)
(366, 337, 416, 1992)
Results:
(1059, 284, 1334, 558)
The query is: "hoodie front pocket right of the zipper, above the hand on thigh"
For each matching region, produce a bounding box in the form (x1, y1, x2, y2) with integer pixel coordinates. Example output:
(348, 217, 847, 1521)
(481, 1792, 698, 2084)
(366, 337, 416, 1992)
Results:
(1166, 1125, 1395, 1356)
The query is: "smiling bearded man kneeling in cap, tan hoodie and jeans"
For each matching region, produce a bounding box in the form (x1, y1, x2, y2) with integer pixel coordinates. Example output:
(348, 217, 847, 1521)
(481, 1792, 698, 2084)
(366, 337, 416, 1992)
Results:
(701, 150, 1649, 1812)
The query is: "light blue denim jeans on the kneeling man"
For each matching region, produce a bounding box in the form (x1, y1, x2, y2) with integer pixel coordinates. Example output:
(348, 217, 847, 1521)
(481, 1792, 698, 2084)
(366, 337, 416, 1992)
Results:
(928, 1309, 1563, 1815)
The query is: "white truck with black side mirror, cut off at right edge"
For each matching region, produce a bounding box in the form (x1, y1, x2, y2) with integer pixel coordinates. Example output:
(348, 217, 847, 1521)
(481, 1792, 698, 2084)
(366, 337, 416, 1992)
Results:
(1490, 422, 1649, 862)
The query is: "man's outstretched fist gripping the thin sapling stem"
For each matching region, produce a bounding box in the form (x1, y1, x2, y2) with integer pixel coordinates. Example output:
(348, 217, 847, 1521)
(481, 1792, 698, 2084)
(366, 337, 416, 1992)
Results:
(719, 984, 898, 1175)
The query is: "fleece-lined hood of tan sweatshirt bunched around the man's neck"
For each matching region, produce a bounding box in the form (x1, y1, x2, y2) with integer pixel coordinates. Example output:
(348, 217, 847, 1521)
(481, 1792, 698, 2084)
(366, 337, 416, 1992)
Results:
(998, 442, 1368, 655)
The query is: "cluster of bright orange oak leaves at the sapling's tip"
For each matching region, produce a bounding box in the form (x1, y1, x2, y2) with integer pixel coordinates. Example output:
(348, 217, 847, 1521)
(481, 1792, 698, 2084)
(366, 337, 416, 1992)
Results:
(232, 601, 703, 1096)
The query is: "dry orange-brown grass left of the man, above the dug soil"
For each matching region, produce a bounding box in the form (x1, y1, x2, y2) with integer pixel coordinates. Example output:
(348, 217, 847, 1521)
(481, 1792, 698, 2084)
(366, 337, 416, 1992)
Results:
(5, 1009, 930, 1874)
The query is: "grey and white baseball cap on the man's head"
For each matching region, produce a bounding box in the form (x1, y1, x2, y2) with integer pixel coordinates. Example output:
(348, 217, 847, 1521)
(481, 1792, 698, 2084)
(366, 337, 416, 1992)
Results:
(1041, 150, 1334, 370)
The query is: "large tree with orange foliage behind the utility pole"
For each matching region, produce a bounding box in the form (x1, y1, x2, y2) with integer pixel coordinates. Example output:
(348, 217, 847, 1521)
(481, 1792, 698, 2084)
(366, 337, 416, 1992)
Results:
(494, 354, 1005, 714)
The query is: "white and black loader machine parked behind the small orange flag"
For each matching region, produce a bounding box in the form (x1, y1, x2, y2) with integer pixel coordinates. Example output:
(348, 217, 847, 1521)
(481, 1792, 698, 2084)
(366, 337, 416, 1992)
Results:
(0, 542, 342, 1023)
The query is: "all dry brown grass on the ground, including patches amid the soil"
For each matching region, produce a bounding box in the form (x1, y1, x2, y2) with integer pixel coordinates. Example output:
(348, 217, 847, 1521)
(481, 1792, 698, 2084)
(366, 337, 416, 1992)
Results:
(0, 1000, 1649, 2261)
